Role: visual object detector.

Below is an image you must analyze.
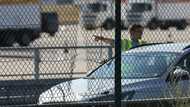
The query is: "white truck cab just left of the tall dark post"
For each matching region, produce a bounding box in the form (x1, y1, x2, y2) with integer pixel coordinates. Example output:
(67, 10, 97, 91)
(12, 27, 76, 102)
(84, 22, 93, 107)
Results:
(81, 1, 114, 30)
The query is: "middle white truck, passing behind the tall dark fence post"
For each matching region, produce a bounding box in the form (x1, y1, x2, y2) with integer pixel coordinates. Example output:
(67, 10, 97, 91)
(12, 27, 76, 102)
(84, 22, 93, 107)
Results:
(81, 0, 127, 30)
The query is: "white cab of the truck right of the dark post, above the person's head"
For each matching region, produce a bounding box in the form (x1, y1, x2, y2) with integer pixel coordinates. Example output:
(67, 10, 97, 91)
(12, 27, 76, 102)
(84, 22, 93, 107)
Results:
(126, 0, 156, 26)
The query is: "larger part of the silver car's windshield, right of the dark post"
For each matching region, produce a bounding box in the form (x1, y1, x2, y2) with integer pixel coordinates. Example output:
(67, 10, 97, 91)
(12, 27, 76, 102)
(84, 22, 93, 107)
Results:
(122, 53, 173, 78)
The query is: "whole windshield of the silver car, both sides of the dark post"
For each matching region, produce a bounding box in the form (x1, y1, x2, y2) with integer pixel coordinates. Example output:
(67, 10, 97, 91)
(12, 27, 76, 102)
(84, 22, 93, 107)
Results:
(88, 52, 178, 78)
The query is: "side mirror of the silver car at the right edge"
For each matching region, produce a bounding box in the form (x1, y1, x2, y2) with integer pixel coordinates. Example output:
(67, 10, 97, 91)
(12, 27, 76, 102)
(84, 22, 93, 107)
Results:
(170, 66, 190, 83)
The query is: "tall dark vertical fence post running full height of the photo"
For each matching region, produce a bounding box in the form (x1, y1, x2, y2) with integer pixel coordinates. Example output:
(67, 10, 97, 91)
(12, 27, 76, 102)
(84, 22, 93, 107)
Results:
(115, 0, 121, 107)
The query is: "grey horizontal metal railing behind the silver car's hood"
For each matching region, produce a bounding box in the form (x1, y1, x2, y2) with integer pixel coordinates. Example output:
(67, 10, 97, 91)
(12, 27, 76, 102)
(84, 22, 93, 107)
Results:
(0, 46, 113, 80)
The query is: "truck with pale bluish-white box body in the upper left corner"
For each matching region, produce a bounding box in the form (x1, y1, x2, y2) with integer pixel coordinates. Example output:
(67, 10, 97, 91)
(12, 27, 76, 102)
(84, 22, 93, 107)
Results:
(0, 0, 59, 47)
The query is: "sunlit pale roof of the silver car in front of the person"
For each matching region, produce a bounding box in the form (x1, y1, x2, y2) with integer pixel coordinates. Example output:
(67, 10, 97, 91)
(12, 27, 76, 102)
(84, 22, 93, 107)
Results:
(125, 43, 190, 53)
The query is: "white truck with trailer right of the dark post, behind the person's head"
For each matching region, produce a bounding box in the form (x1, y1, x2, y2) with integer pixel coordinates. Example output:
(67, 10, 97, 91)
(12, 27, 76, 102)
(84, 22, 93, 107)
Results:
(126, 0, 190, 30)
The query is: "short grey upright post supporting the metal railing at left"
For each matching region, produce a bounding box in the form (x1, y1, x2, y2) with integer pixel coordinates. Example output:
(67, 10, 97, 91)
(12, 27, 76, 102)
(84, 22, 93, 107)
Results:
(33, 48, 41, 80)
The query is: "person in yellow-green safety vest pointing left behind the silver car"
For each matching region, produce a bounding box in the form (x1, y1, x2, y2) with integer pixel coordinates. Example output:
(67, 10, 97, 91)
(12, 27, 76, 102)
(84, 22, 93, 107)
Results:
(94, 24, 146, 51)
